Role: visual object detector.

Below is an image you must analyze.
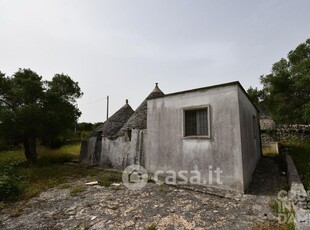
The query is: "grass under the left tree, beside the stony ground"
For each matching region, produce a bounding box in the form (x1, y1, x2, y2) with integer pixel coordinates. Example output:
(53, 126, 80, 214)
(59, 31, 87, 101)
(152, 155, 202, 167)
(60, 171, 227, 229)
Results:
(0, 144, 121, 202)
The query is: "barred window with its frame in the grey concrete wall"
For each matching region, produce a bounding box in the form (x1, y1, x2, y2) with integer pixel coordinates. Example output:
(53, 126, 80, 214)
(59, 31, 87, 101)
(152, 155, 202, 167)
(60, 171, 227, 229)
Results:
(184, 107, 210, 137)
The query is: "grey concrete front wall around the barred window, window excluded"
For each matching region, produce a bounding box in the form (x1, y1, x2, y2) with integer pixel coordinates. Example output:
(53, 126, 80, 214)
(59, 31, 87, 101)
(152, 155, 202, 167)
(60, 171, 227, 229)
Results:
(145, 85, 245, 192)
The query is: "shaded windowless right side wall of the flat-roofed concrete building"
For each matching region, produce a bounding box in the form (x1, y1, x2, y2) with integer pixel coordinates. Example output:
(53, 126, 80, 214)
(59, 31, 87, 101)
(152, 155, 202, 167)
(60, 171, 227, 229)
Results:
(238, 88, 261, 191)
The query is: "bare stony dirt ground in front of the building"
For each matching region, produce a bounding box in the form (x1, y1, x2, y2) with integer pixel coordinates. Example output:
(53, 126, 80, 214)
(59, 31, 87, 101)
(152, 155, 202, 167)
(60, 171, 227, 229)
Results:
(0, 158, 287, 229)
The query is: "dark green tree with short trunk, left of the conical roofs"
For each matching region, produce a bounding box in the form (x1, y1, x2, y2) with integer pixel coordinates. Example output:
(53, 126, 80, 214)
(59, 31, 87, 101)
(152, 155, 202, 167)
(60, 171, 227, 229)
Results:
(0, 69, 82, 162)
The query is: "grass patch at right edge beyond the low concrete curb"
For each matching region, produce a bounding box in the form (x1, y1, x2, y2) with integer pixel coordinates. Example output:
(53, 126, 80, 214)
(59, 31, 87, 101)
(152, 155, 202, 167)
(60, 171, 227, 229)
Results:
(282, 141, 310, 190)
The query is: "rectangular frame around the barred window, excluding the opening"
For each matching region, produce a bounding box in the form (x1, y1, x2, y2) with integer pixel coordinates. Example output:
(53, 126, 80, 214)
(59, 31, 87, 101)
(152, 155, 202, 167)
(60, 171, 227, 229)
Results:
(182, 105, 211, 139)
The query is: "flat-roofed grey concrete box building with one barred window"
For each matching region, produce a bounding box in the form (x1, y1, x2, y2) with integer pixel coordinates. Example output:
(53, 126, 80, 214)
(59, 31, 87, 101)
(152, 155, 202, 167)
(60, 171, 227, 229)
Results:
(145, 82, 261, 192)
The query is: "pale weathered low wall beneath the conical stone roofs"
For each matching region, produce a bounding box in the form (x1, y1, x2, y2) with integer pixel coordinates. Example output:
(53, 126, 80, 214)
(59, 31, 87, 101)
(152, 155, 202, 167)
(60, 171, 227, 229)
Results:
(99, 129, 146, 168)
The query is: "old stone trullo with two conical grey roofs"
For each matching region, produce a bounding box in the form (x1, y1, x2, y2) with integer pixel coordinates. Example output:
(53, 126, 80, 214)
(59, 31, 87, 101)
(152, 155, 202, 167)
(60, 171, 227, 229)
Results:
(80, 84, 164, 168)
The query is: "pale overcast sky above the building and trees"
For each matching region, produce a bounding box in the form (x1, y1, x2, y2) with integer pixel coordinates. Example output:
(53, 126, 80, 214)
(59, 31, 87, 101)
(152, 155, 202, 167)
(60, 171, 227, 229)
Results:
(0, 0, 310, 122)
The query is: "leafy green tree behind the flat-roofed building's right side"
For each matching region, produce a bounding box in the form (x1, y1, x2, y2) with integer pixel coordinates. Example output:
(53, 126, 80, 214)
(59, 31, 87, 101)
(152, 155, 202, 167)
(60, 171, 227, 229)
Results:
(248, 39, 310, 124)
